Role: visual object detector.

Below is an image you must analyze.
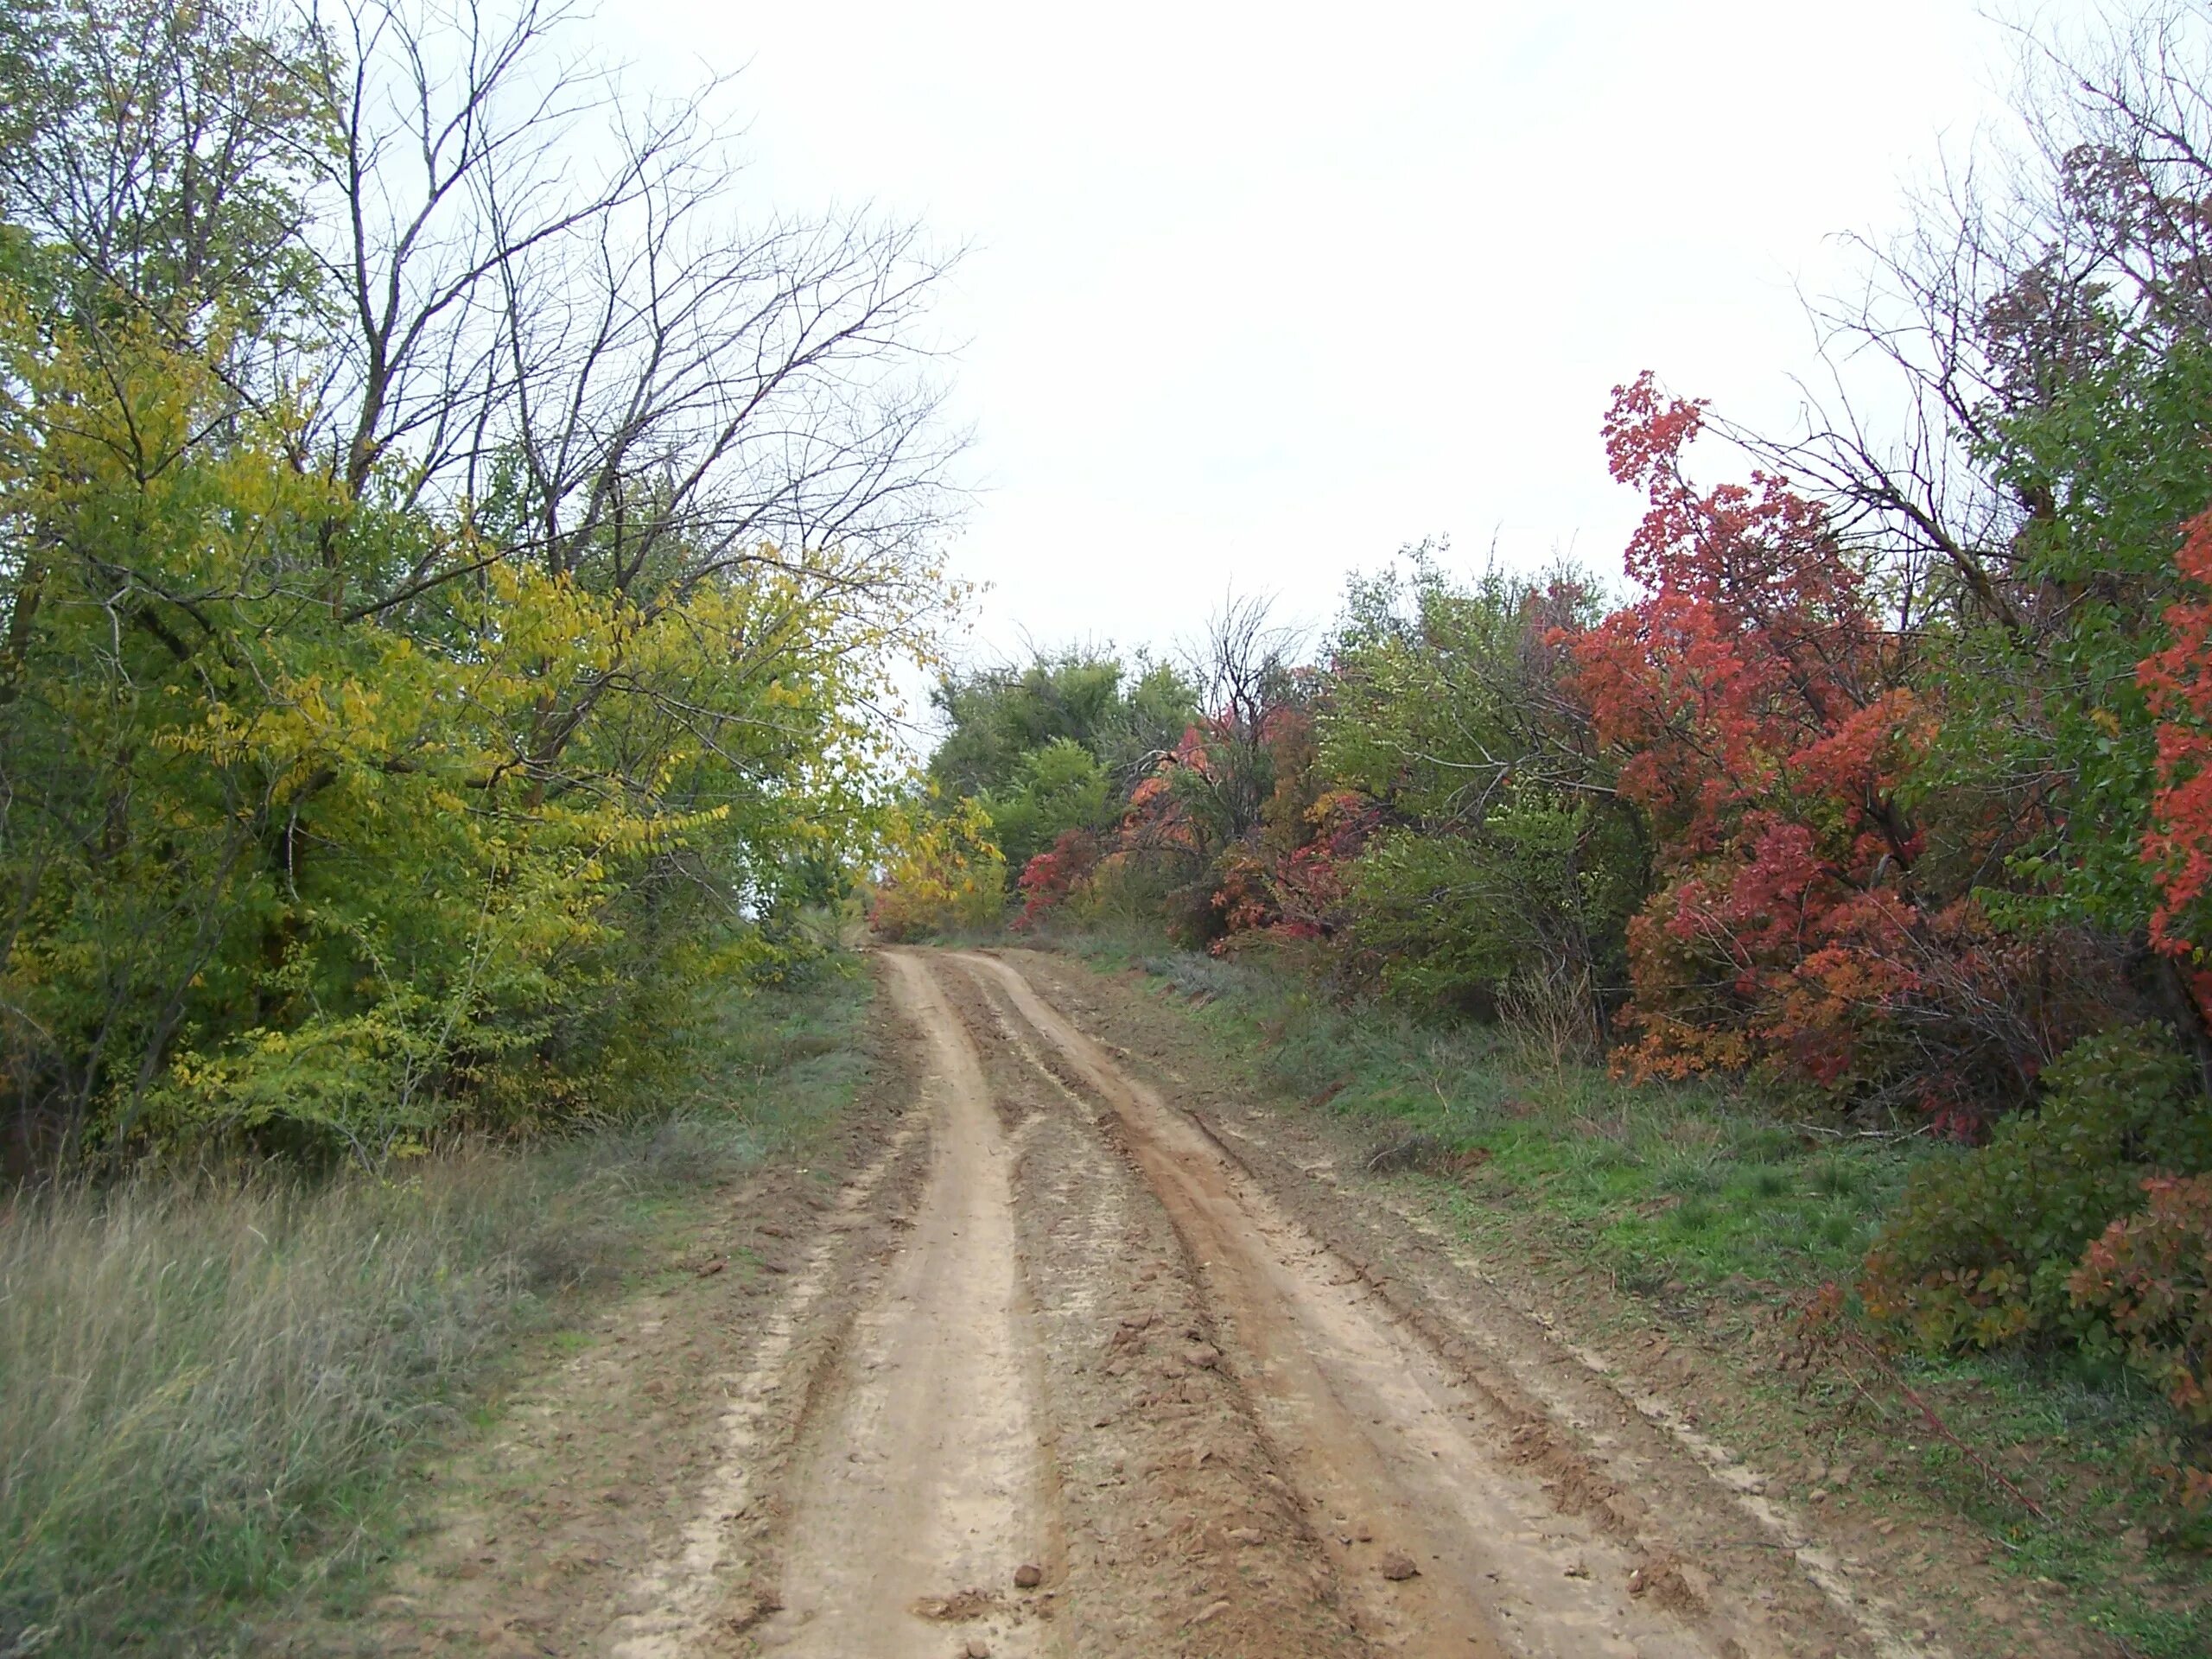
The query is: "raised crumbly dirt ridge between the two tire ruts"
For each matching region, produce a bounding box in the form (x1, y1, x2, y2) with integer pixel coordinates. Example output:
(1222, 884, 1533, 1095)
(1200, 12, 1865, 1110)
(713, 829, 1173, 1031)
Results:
(943, 971, 1371, 1659)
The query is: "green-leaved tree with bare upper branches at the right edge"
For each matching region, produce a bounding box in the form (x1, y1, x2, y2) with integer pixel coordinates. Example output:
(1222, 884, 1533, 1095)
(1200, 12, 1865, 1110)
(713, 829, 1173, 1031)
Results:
(1737, 4, 2212, 1089)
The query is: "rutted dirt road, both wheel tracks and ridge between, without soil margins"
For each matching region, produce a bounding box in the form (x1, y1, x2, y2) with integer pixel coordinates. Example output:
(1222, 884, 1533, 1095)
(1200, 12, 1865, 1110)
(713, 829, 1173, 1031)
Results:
(721, 951, 1920, 1659)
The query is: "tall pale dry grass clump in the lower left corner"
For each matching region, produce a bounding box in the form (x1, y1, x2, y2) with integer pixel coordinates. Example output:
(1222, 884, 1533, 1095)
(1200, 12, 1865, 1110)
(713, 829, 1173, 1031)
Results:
(0, 1159, 533, 1652)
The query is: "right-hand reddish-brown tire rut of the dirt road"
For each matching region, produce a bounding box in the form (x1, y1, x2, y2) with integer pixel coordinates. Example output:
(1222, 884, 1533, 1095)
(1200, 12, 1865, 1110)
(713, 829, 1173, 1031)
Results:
(956, 953, 1745, 1659)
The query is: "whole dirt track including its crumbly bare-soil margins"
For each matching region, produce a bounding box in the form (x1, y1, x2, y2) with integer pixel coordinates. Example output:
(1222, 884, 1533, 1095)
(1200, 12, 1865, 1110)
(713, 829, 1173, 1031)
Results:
(307, 951, 1973, 1659)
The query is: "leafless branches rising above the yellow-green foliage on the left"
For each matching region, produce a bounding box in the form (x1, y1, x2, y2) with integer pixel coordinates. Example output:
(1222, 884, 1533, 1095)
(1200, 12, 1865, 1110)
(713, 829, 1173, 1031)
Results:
(289, 0, 960, 615)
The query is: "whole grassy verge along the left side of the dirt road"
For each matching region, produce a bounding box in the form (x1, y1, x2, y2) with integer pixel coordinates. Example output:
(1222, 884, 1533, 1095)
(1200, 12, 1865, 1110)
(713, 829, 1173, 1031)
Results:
(0, 971, 869, 1659)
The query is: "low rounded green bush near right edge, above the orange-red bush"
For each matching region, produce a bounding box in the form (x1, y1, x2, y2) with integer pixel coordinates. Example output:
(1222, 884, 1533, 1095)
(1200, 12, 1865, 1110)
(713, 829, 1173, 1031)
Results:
(1860, 1027, 2212, 1350)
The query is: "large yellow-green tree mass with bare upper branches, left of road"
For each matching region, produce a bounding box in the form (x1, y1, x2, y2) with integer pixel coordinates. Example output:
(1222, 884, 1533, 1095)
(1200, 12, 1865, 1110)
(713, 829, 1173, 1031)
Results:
(0, 0, 956, 1157)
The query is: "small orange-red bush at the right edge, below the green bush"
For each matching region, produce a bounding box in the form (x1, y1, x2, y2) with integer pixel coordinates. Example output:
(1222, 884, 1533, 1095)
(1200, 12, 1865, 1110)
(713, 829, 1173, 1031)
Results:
(2069, 1174, 2212, 1509)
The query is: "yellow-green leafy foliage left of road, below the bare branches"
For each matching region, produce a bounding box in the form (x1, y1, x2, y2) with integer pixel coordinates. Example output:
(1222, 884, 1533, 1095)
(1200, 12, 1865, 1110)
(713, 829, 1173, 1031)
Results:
(0, 315, 915, 1154)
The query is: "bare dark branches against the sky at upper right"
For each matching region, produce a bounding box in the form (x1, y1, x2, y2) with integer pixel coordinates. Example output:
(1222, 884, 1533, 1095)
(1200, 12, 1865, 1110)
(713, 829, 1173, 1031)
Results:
(1721, 0, 2212, 651)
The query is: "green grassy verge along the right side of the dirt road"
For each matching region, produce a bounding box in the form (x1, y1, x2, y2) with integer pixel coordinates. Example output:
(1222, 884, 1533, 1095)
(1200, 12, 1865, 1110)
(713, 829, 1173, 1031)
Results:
(1039, 936, 2212, 1659)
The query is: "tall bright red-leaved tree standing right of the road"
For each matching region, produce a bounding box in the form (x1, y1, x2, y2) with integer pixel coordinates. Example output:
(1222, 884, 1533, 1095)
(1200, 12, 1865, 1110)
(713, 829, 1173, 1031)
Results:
(1571, 374, 2002, 1113)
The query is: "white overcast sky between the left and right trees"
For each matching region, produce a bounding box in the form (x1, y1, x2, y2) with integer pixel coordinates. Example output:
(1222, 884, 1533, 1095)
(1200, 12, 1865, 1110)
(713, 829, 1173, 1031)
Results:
(600, 0, 2075, 652)
